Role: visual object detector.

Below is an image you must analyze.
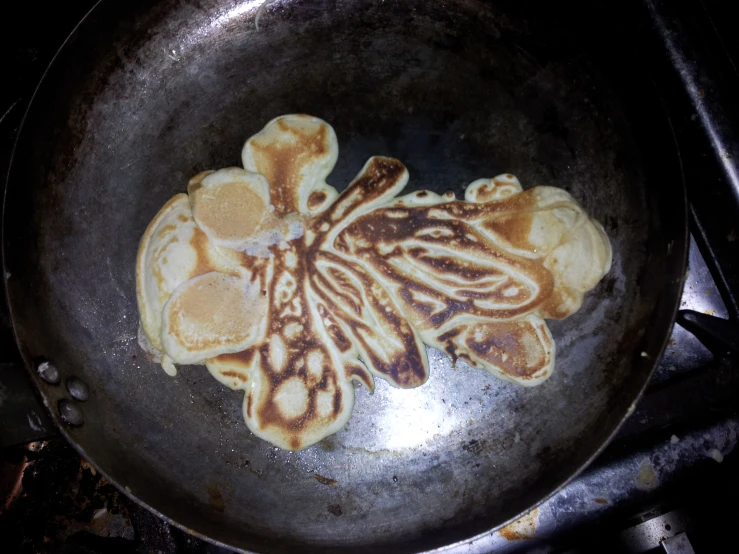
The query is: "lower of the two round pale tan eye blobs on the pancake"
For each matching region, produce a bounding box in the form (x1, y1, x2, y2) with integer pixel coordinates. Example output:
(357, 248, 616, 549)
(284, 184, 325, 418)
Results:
(162, 271, 267, 364)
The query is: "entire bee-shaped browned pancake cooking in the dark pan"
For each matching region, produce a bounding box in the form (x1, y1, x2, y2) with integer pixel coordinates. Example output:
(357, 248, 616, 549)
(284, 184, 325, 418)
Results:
(136, 115, 611, 450)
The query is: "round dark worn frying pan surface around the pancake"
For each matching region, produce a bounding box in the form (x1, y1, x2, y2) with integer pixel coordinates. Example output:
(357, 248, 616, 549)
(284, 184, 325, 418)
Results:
(3, 0, 687, 552)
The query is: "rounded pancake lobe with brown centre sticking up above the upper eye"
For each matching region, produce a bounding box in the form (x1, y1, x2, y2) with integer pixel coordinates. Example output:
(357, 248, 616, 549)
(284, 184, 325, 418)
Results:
(241, 115, 339, 215)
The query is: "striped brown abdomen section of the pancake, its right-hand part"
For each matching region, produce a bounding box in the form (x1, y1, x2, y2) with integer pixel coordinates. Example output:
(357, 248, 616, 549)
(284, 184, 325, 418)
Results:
(335, 175, 611, 386)
